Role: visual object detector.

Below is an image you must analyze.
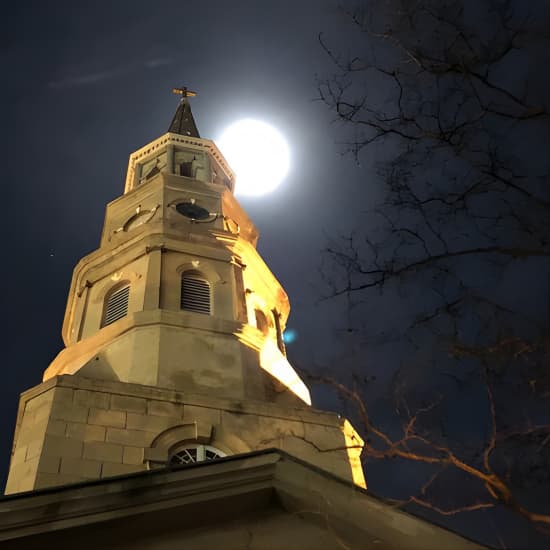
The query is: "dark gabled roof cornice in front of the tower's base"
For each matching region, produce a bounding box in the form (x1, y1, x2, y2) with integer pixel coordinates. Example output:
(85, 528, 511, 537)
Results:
(0, 449, 490, 550)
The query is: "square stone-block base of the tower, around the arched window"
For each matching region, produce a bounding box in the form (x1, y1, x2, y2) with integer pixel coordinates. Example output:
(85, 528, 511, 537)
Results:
(6, 375, 364, 493)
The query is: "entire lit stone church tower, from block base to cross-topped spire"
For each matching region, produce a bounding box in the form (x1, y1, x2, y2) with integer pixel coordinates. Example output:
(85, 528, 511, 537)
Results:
(6, 87, 365, 493)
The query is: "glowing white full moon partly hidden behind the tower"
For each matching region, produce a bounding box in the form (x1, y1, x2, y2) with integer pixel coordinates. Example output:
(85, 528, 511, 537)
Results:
(217, 118, 290, 195)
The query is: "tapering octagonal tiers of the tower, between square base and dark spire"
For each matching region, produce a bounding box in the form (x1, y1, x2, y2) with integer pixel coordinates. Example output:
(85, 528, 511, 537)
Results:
(44, 133, 309, 410)
